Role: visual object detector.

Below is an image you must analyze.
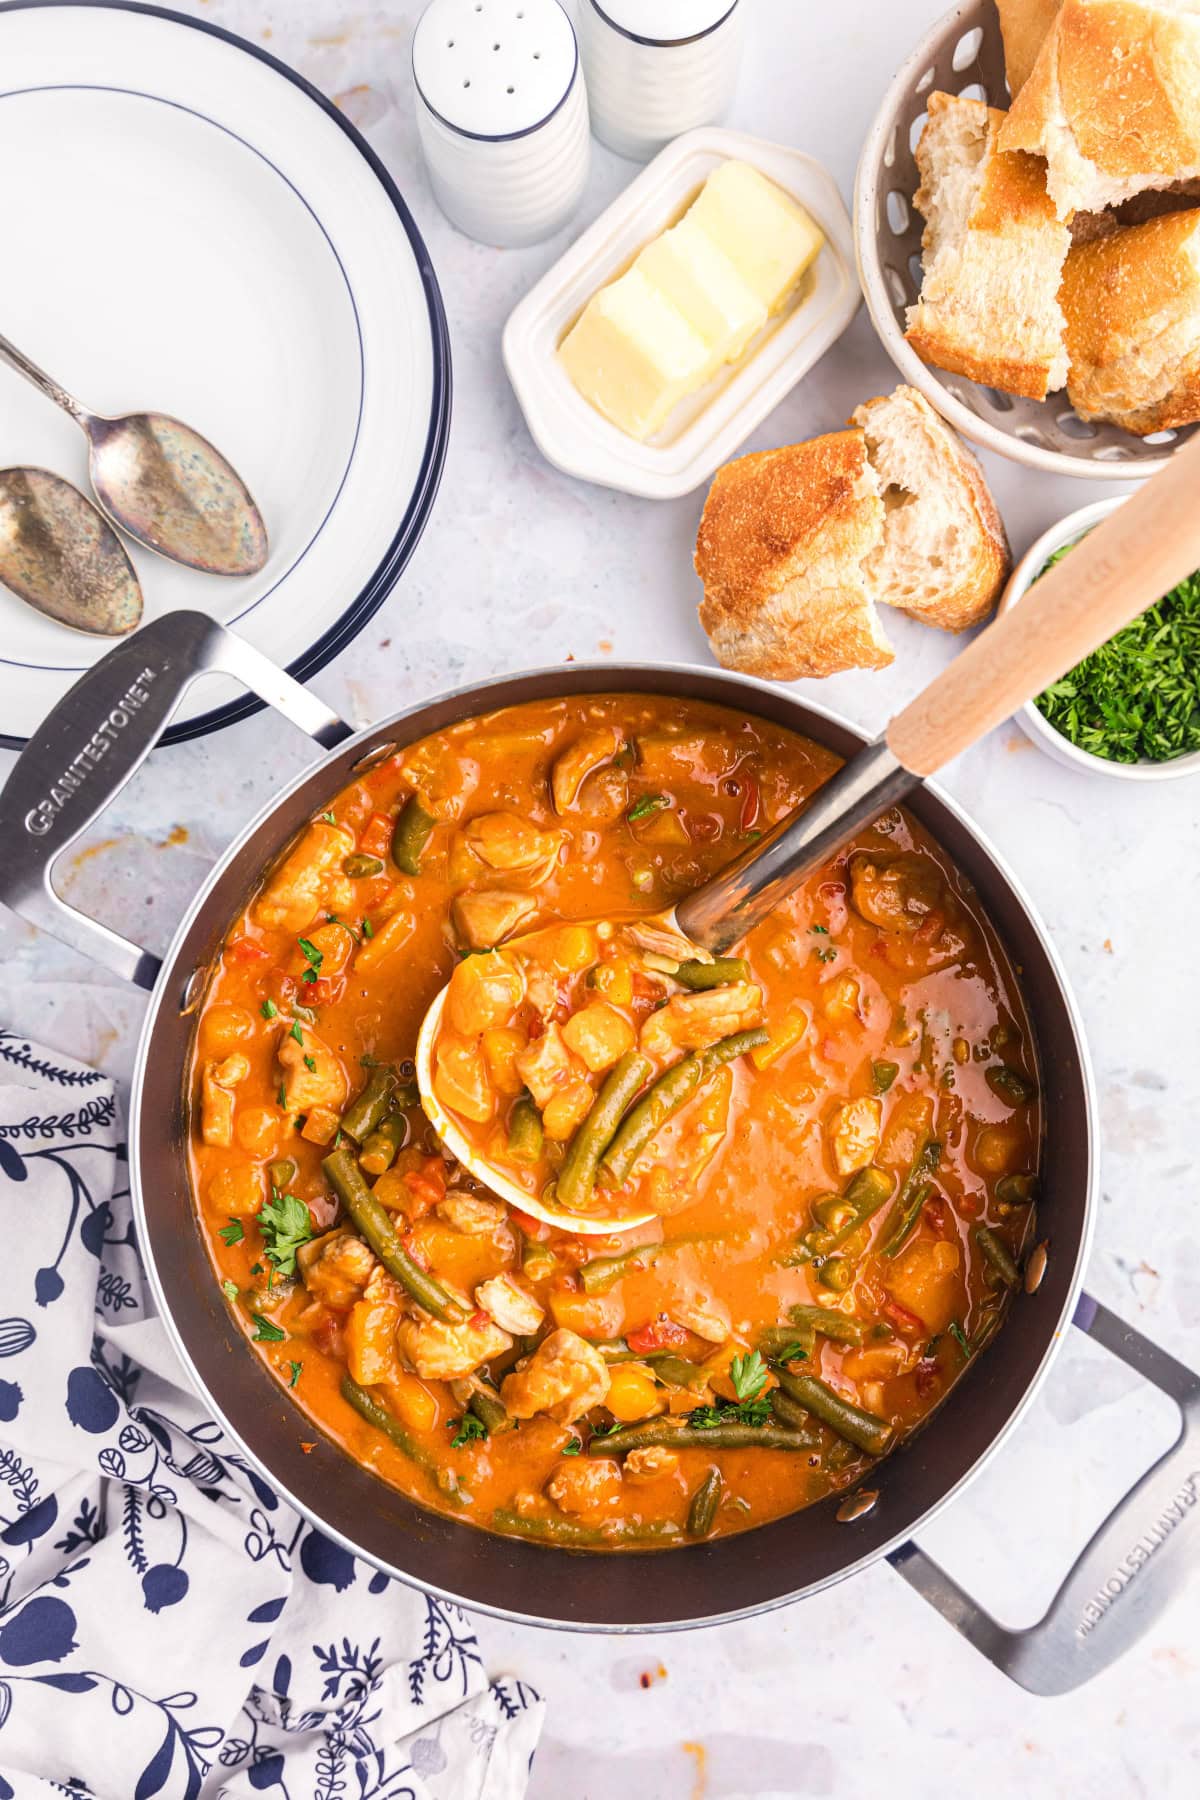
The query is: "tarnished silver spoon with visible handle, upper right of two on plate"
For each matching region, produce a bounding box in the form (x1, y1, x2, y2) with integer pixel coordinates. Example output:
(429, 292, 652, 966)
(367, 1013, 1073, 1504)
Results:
(0, 337, 266, 574)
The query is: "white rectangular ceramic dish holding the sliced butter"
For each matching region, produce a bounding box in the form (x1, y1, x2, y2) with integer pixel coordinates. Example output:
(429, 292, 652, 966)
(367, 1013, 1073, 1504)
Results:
(504, 126, 860, 500)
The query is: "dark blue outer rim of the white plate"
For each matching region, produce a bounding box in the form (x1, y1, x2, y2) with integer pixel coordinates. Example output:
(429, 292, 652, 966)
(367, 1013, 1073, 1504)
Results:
(0, 0, 453, 751)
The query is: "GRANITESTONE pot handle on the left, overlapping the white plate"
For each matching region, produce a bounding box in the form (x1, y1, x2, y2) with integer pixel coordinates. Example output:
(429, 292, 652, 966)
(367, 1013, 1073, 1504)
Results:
(0, 612, 351, 988)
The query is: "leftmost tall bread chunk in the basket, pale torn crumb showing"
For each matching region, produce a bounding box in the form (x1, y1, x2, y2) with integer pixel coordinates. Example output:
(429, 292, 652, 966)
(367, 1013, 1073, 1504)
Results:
(905, 94, 1070, 400)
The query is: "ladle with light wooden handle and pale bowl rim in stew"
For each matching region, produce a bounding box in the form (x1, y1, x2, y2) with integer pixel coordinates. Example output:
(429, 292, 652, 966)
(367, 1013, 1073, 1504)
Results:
(416, 437, 1200, 1235)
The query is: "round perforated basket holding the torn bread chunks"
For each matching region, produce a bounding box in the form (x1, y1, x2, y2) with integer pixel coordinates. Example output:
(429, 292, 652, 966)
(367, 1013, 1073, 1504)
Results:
(855, 0, 1195, 481)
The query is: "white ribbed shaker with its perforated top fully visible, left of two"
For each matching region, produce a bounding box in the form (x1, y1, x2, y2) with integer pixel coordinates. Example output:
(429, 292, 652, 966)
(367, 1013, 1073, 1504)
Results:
(412, 0, 590, 247)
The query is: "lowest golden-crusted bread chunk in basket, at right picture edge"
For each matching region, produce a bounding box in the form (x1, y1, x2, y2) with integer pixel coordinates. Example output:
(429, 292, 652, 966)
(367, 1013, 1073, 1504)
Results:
(1061, 207, 1200, 437)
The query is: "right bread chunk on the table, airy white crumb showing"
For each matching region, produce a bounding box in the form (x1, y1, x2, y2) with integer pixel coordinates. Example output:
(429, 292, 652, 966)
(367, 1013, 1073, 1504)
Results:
(853, 387, 1011, 632)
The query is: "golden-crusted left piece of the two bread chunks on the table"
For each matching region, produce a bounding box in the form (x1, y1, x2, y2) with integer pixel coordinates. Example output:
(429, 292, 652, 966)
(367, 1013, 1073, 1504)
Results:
(694, 430, 892, 680)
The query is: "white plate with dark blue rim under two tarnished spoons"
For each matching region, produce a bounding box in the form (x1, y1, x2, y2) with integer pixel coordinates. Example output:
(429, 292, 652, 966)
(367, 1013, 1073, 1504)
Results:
(0, 0, 450, 747)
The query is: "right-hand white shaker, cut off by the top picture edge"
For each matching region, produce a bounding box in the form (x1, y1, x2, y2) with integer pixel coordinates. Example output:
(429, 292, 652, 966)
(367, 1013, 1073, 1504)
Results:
(576, 0, 745, 162)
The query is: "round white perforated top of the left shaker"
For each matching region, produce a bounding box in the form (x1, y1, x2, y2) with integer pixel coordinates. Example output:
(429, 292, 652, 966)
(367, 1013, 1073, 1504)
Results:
(412, 0, 578, 139)
